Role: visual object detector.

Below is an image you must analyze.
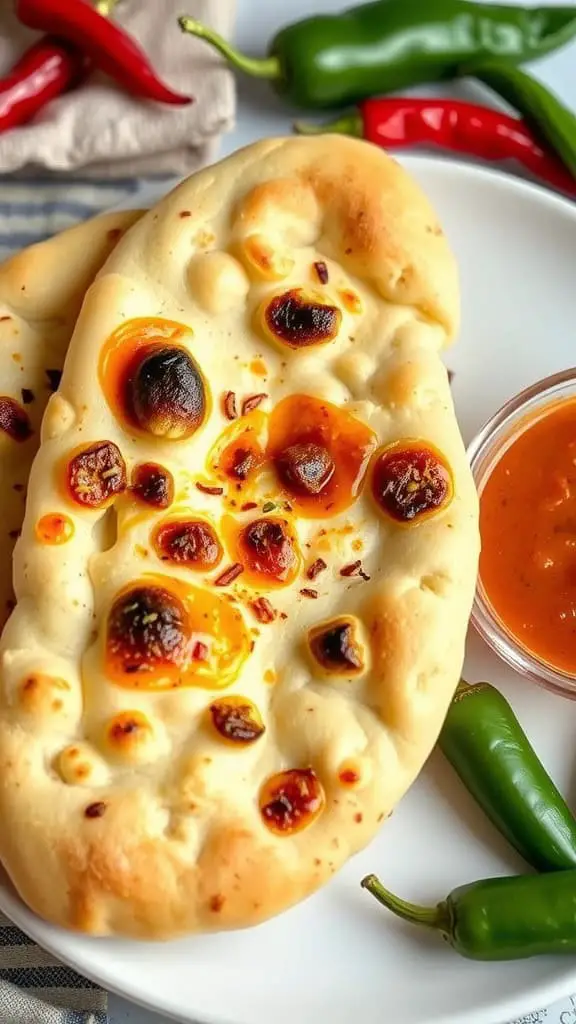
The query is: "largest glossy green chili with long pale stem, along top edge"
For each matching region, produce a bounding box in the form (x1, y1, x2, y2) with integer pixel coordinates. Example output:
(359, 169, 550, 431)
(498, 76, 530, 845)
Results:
(178, 0, 576, 108)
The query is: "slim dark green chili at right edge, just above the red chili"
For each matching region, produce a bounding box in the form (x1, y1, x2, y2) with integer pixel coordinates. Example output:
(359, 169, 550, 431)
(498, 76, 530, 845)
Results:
(466, 61, 576, 178)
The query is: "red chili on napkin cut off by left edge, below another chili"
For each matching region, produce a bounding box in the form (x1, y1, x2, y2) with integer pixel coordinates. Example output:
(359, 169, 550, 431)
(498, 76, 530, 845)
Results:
(0, 36, 89, 131)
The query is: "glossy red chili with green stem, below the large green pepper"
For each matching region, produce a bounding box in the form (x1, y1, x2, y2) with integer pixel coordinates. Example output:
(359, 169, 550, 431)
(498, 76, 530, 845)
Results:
(294, 96, 576, 196)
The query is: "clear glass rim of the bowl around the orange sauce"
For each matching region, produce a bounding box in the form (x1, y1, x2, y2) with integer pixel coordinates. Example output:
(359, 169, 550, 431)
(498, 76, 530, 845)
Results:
(467, 367, 576, 700)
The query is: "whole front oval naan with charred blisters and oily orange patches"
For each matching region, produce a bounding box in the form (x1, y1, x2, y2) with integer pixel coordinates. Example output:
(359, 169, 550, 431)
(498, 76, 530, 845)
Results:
(0, 136, 479, 938)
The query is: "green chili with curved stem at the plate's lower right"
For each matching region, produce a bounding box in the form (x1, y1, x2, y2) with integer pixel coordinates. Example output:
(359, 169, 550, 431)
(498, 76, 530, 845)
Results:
(361, 871, 576, 961)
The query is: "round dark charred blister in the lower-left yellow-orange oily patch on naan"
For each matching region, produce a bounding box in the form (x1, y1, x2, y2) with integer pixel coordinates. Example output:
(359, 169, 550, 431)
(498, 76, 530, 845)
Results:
(107, 585, 189, 675)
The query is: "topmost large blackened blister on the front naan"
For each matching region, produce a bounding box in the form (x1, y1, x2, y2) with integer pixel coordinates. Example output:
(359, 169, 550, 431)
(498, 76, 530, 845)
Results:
(261, 288, 342, 349)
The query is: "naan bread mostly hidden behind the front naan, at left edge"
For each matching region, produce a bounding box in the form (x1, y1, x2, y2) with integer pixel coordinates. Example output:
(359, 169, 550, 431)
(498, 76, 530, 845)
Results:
(0, 212, 139, 628)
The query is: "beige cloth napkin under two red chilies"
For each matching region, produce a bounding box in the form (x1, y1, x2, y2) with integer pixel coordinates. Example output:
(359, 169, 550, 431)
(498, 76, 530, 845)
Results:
(0, 0, 235, 178)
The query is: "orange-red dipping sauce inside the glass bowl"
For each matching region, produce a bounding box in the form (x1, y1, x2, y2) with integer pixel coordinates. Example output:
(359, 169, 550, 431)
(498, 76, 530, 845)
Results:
(480, 398, 576, 676)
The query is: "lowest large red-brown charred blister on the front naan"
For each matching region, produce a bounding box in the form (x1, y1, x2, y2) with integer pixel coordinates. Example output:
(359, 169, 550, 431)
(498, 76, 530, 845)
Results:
(259, 768, 325, 836)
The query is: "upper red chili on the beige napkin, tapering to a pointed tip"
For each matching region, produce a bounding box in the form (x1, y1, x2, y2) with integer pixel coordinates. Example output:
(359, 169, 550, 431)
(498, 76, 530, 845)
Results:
(16, 0, 192, 104)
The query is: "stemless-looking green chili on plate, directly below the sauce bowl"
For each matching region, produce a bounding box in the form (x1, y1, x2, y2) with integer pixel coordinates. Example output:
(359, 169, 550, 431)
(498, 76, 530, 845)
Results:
(439, 681, 576, 871)
